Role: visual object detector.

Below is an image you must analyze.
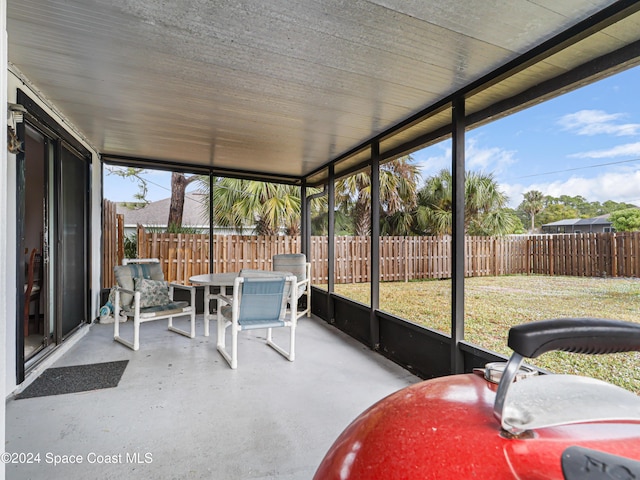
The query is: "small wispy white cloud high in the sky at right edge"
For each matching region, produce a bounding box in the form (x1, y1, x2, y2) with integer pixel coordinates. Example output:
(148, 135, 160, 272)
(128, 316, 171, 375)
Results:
(558, 110, 640, 136)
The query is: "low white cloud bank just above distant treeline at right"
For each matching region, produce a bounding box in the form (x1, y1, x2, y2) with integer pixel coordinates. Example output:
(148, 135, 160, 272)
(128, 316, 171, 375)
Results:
(500, 167, 640, 208)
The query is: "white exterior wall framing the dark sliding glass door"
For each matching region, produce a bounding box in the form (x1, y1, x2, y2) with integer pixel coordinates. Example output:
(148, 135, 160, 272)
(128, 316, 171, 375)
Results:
(0, 68, 102, 398)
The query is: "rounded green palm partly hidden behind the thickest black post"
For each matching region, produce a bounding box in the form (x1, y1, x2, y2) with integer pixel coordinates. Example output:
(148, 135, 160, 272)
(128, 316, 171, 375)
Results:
(415, 169, 516, 235)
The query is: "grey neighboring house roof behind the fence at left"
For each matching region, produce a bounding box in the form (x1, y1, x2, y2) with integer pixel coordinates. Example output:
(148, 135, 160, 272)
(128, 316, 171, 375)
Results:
(116, 193, 209, 227)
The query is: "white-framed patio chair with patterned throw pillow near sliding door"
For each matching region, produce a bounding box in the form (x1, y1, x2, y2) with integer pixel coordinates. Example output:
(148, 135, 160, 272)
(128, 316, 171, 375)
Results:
(113, 258, 196, 350)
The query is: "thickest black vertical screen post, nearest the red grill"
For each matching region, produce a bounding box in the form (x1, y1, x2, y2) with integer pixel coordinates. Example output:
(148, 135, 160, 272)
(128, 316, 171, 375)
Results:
(451, 97, 466, 374)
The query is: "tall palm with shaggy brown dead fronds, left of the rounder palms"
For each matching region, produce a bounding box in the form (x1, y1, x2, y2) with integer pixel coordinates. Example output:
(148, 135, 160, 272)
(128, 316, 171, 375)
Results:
(336, 155, 420, 236)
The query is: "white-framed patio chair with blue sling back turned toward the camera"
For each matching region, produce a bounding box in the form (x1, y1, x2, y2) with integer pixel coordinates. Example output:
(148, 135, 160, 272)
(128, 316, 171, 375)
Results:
(217, 270, 298, 369)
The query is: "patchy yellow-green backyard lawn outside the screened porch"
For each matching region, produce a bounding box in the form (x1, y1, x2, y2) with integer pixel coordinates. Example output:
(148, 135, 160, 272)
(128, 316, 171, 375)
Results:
(335, 275, 640, 393)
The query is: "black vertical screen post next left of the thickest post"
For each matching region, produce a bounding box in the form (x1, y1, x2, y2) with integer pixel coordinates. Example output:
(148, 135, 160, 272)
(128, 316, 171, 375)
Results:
(369, 141, 380, 350)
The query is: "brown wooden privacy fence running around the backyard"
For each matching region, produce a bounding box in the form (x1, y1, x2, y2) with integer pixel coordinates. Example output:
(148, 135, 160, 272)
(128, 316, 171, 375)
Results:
(104, 224, 640, 287)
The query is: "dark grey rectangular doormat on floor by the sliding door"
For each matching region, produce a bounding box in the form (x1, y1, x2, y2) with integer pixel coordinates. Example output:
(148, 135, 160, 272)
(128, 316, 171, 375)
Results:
(16, 360, 129, 399)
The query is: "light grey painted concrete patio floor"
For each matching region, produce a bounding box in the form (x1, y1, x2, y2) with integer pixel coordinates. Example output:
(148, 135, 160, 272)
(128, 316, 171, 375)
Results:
(5, 316, 420, 480)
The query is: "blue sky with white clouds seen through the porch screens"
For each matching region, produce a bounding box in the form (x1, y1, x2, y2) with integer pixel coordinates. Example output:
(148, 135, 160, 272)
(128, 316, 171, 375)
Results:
(104, 67, 640, 208)
